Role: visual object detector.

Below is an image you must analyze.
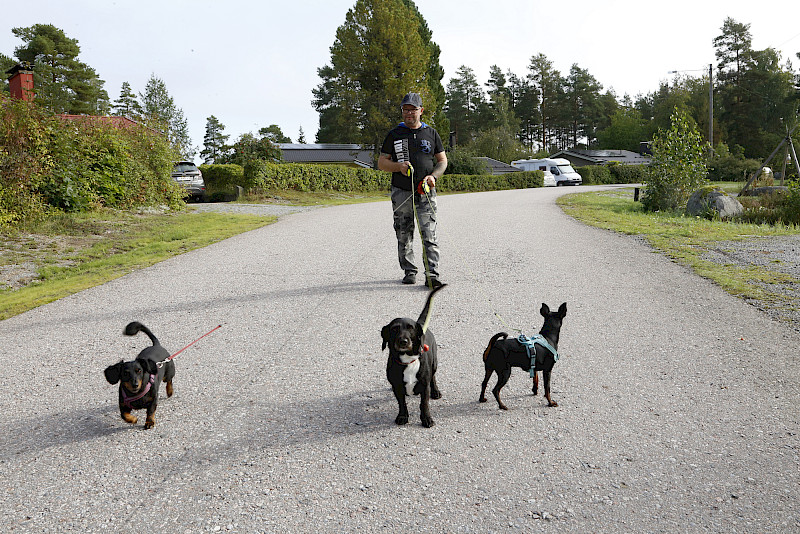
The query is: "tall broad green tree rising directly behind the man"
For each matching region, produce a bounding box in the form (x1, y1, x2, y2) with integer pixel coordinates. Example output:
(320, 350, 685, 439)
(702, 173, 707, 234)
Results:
(312, 0, 444, 147)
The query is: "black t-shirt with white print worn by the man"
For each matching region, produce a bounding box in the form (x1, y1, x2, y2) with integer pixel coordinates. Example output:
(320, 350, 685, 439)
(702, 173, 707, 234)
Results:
(381, 122, 444, 191)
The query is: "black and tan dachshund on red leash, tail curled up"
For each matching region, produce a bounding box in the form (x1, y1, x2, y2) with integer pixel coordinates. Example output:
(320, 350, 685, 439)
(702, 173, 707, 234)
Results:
(105, 321, 175, 429)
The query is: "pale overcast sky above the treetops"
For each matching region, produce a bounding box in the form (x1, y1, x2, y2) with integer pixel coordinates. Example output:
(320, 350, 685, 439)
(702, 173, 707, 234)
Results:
(0, 0, 800, 159)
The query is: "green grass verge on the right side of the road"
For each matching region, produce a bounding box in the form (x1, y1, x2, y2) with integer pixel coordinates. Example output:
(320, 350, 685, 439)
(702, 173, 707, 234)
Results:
(558, 188, 800, 304)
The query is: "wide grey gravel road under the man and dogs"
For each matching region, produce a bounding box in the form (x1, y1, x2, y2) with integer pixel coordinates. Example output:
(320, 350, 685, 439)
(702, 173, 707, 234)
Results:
(0, 187, 800, 533)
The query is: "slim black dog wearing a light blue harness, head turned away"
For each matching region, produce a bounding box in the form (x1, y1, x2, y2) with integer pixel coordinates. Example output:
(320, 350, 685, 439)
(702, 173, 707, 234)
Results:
(480, 302, 567, 410)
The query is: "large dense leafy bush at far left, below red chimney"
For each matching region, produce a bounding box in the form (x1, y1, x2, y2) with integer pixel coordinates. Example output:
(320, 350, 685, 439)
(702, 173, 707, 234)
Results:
(0, 98, 185, 227)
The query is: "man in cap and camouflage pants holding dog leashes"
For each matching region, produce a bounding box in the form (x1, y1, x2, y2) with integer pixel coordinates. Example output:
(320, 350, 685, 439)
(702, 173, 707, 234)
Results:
(378, 93, 447, 289)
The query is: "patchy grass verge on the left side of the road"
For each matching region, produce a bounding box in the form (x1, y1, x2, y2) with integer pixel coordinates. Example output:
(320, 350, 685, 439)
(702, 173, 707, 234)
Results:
(0, 212, 276, 320)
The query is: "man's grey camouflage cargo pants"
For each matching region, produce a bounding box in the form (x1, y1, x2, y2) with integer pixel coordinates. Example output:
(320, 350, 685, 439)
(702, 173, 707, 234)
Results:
(392, 187, 439, 279)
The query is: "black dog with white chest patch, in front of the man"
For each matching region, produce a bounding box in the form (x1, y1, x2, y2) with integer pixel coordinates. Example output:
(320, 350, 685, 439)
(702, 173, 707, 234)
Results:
(381, 284, 447, 428)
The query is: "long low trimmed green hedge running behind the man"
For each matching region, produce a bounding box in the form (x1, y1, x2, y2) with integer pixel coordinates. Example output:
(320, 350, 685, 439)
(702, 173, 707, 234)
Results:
(200, 164, 544, 198)
